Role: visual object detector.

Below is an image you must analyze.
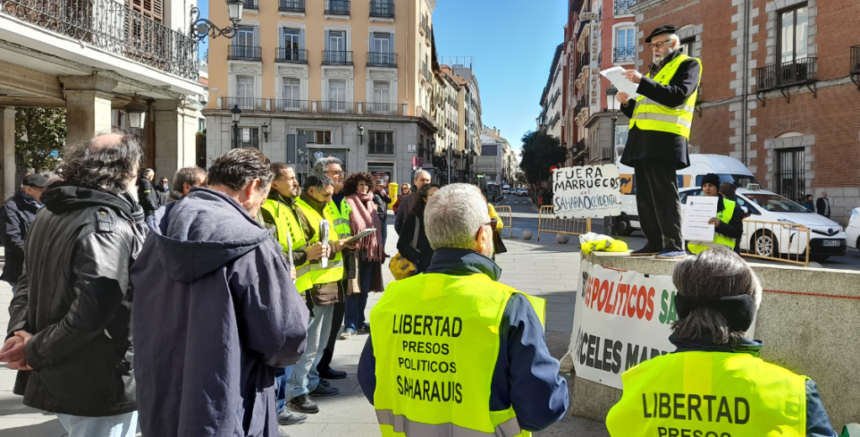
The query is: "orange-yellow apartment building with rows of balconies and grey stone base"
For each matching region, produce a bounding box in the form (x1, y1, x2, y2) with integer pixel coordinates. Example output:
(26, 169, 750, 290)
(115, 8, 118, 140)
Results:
(204, 0, 444, 182)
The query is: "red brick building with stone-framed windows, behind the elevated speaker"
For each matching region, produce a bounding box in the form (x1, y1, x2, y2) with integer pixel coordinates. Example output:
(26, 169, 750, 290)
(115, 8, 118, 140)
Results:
(631, 0, 860, 224)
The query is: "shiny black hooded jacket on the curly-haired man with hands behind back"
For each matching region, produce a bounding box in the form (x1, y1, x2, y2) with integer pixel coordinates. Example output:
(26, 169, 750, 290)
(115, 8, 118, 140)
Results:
(7, 186, 145, 417)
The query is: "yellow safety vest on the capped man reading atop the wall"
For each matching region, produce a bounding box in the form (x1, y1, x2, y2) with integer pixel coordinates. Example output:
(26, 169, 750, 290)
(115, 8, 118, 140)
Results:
(630, 53, 702, 140)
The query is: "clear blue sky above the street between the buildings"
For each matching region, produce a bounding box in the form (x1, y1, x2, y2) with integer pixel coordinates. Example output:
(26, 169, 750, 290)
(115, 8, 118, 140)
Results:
(199, 0, 567, 148)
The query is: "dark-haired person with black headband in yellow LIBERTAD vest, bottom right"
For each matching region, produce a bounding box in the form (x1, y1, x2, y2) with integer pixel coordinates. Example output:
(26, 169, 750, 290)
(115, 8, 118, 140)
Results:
(606, 248, 836, 437)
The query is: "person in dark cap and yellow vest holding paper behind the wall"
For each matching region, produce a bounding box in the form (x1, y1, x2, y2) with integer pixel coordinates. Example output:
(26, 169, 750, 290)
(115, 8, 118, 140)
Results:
(687, 173, 744, 254)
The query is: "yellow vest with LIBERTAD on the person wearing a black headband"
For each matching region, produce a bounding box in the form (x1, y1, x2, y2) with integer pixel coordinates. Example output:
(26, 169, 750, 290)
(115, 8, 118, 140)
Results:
(606, 352, 807, 437)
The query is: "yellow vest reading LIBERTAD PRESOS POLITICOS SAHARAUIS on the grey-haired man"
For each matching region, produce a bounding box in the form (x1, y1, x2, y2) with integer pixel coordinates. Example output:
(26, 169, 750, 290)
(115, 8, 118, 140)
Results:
(370, 274, 546, 437)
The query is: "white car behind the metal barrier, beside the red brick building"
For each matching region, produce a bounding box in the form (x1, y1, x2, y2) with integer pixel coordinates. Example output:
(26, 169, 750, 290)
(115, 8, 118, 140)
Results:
(680, 187, 848, 261)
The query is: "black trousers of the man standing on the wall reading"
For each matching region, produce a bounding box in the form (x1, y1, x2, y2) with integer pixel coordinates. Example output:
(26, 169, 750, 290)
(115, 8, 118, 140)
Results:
(633, 158, 684, 252)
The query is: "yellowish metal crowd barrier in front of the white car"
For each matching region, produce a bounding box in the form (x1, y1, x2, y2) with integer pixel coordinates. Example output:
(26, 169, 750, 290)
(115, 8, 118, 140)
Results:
(741, 220, 811, 267)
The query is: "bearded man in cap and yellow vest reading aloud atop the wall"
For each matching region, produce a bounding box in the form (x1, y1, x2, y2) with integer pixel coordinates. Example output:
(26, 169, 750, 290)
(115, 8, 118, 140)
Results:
(616, 25, 702, 259)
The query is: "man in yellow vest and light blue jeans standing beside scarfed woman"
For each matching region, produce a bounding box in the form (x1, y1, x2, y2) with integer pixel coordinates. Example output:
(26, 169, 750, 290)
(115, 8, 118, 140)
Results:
(286, 174, 355, 414)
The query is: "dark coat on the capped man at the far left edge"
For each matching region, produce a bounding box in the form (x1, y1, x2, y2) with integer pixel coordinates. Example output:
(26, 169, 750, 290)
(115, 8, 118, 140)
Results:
(0, 189, 42, 282)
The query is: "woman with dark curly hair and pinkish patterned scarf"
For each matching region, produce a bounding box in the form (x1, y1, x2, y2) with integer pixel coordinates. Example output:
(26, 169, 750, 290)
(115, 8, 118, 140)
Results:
(341, 173, 385, 339)
